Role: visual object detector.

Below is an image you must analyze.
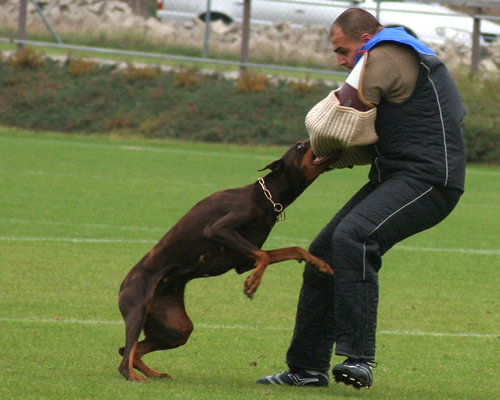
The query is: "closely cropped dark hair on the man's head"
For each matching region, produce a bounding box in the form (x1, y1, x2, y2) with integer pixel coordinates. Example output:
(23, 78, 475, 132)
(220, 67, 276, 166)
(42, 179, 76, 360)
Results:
(330, 8, 383, 40)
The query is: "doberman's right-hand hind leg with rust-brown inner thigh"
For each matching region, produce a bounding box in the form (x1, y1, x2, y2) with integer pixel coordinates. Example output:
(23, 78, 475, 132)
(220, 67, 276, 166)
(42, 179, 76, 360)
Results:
(133, 284, 193, 378)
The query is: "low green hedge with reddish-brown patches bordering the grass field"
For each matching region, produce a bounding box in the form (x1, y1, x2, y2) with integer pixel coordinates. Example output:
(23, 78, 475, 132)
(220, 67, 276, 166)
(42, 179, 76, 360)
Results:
(0, 52, 500, 162)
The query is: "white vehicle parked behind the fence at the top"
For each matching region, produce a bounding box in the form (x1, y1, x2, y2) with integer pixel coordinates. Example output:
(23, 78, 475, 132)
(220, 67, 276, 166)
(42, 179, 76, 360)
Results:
(157, 0, 500, 44)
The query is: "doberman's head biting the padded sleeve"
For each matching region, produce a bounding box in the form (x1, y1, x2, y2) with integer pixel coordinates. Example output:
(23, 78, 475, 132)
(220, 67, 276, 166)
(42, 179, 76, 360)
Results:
(259, 141, 341, 184)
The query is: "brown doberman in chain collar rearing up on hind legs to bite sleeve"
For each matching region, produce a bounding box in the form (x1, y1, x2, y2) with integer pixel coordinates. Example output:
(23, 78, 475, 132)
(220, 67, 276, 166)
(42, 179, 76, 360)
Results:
(118, 142, 339, 381)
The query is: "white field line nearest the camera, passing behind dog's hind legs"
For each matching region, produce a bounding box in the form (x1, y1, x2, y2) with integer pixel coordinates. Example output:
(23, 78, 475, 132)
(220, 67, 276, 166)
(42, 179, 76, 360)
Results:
(0, 318, 500, 338)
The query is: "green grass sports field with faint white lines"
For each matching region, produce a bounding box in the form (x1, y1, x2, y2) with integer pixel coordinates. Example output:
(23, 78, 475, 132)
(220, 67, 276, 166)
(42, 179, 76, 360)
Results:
(0, 128, 500, 400)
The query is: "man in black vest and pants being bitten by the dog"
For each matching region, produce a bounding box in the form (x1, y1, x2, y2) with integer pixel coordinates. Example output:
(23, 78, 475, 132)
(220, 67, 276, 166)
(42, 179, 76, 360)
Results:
(257, 8, 465, 388)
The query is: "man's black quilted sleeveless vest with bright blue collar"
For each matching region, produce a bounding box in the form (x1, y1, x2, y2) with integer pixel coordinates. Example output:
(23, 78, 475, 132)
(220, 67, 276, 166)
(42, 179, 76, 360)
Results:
(361, 28, 466, 190)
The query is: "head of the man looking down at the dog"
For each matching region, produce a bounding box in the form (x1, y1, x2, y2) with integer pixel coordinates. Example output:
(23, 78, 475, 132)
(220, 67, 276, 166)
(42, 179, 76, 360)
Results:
(330, 8, 384, 72)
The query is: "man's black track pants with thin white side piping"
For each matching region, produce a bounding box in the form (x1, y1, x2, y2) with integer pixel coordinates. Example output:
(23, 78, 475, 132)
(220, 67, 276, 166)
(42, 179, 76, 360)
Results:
(287, 177, 462, 371)
